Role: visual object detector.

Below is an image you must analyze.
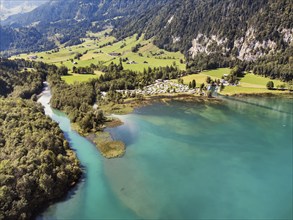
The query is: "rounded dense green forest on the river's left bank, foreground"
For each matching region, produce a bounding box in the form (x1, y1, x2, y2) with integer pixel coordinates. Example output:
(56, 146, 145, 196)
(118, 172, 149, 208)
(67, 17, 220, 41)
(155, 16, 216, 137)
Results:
(0, 98, 81, 219)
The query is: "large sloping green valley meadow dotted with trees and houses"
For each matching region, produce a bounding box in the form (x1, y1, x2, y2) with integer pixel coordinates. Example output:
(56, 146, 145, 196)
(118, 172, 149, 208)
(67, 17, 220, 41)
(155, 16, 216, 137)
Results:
(11, 30, 185, 83)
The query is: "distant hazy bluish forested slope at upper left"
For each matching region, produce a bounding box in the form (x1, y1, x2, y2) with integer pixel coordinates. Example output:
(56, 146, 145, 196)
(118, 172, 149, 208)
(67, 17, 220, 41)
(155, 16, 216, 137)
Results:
(0, 0, 168, 55)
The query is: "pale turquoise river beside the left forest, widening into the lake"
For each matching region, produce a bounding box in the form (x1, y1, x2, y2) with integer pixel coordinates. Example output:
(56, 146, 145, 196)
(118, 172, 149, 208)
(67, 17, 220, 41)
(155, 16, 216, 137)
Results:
(36, 83, 138, 219)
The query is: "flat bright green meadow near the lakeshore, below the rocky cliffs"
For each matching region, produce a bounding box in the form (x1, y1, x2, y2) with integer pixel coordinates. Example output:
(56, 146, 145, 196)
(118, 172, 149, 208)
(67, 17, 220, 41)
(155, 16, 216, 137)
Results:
(178, 68, 284, 95)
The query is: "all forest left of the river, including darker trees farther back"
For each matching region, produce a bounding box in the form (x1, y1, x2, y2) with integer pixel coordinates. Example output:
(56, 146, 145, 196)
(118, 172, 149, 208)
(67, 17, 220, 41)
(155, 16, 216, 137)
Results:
(0, 59, 81, 219)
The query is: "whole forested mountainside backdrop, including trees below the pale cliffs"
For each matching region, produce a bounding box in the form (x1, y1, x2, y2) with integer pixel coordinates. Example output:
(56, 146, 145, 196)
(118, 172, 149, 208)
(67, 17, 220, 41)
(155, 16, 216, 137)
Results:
(0, 0, 293, 81)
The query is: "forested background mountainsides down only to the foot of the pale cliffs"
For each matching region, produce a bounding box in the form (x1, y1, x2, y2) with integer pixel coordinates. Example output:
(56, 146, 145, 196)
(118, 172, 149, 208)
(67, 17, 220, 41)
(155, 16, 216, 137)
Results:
(2, 0, 293, 57)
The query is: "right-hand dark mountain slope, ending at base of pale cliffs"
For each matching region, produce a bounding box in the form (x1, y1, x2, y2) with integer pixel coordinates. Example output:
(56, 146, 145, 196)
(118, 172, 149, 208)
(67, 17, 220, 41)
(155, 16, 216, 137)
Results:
(115, 0, 293, 60)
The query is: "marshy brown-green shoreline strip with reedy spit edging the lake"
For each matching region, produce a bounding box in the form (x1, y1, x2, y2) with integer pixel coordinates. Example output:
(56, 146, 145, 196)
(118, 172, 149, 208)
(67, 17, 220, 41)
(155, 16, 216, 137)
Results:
(71, 92, 293, 159)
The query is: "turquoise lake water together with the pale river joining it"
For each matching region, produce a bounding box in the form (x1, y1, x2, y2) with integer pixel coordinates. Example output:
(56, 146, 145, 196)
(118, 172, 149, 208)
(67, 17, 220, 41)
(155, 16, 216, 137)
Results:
(38, 87, 293, 219)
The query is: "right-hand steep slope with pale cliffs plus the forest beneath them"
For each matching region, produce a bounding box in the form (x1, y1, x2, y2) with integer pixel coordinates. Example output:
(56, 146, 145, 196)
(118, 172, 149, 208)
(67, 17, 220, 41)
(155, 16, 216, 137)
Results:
(113, 0, 293, 81)
